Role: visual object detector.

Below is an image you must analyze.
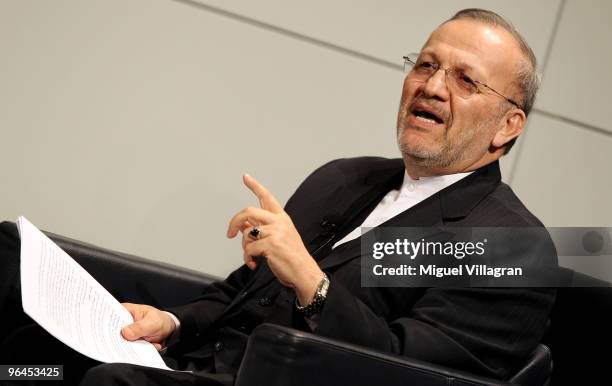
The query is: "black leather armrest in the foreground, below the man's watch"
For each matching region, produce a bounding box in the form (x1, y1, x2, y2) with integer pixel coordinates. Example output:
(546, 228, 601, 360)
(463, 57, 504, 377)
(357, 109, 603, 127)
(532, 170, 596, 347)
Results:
(236, 324, 509, 386)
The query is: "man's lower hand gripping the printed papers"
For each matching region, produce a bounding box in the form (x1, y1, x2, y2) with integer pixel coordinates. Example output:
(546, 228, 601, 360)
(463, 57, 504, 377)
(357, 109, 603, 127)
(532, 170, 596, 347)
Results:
(121, 303, 176, 351)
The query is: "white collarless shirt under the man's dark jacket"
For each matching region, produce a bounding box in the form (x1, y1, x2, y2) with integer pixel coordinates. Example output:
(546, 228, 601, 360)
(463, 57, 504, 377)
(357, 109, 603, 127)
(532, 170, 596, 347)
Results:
(332, 171, 472, 249)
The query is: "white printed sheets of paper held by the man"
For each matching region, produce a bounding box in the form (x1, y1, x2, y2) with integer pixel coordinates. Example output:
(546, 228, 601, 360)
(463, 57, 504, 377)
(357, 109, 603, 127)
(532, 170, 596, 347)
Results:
(17, 217, 171, 370)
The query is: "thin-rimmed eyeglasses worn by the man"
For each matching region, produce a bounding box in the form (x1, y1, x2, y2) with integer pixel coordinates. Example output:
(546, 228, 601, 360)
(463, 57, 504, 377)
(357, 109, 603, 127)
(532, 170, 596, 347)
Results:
(403, 54, 521, 109)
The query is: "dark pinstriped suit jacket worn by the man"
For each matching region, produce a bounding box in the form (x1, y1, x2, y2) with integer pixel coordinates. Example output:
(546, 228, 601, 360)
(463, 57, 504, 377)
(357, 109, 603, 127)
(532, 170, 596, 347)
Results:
(165, 157, 555, 378)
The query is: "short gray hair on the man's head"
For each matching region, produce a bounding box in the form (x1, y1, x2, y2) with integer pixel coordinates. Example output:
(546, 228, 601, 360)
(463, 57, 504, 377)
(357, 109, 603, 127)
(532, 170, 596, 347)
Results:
(445, 8, 541, 154)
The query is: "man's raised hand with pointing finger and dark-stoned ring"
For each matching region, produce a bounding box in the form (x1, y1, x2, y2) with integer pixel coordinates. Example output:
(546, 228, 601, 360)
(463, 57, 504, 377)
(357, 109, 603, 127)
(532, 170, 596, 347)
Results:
(227, 174, 324, 305)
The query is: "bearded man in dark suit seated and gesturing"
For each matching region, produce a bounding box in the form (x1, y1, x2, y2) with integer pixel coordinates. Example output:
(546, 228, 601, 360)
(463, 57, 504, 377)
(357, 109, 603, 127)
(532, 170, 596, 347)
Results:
(0, 10, 555, 384)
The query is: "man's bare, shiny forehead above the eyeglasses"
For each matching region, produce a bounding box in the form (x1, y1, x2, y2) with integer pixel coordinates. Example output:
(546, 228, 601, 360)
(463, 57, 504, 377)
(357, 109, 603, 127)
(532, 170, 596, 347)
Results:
(421, 20, 521, 77)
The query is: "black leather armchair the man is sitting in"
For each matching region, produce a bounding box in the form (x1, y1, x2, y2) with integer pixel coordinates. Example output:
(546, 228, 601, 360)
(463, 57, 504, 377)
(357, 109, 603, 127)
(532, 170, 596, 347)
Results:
(0, 222, 612, 386)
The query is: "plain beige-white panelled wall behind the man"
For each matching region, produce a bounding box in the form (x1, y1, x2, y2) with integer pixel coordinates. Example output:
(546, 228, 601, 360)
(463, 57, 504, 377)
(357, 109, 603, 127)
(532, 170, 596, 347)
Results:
(0, 0, 612, 278)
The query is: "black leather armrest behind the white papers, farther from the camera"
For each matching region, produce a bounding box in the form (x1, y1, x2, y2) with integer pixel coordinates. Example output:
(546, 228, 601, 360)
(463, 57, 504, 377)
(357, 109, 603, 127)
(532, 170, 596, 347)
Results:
(1, 222, 219, 308)
